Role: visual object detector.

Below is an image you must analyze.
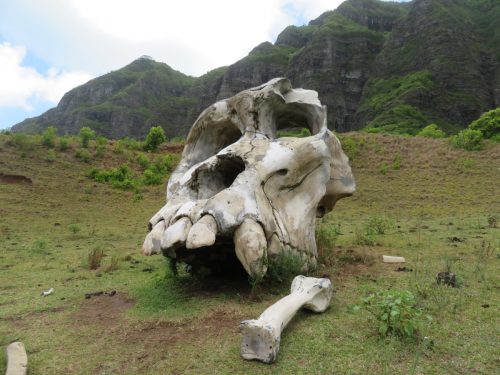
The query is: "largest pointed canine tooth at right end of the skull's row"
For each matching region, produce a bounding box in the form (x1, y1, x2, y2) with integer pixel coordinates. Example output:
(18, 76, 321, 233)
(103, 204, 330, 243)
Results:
(234, 219, 267, 276)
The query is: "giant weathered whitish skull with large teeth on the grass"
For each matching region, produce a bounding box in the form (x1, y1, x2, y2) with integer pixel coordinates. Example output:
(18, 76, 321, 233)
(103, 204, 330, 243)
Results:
(143, 78, 355, 276)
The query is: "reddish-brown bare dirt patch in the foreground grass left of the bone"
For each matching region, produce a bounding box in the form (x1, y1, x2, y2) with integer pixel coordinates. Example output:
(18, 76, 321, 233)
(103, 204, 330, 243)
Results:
(72, 293, 135, 325)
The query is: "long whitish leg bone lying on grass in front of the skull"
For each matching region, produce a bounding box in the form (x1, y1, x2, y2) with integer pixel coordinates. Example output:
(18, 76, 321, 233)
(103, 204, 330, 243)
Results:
(240, 276, 333, 363)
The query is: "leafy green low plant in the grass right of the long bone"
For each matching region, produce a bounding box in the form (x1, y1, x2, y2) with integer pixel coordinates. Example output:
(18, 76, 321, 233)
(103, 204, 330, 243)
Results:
(358, 290, 431, 339)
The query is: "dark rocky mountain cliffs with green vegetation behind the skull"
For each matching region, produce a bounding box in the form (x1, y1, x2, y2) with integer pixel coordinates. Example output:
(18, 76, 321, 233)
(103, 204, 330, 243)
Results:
(14, 0, 500, 138)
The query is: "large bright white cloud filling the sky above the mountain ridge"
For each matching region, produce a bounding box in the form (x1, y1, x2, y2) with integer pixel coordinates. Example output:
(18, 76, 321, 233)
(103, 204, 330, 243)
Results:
(0, 0, 341, 75)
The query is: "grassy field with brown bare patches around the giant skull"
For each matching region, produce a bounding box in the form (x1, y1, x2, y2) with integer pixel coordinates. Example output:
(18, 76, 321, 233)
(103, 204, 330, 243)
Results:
(0, 133, 500, 374)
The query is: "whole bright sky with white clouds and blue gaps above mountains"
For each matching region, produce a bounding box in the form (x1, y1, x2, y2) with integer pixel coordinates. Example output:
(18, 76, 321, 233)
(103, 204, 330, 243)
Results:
(0, 0, 406, 129)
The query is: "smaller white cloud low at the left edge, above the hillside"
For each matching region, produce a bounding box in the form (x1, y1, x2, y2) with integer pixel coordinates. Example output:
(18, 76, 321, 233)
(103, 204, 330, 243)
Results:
(0, 43, 92, 111)
